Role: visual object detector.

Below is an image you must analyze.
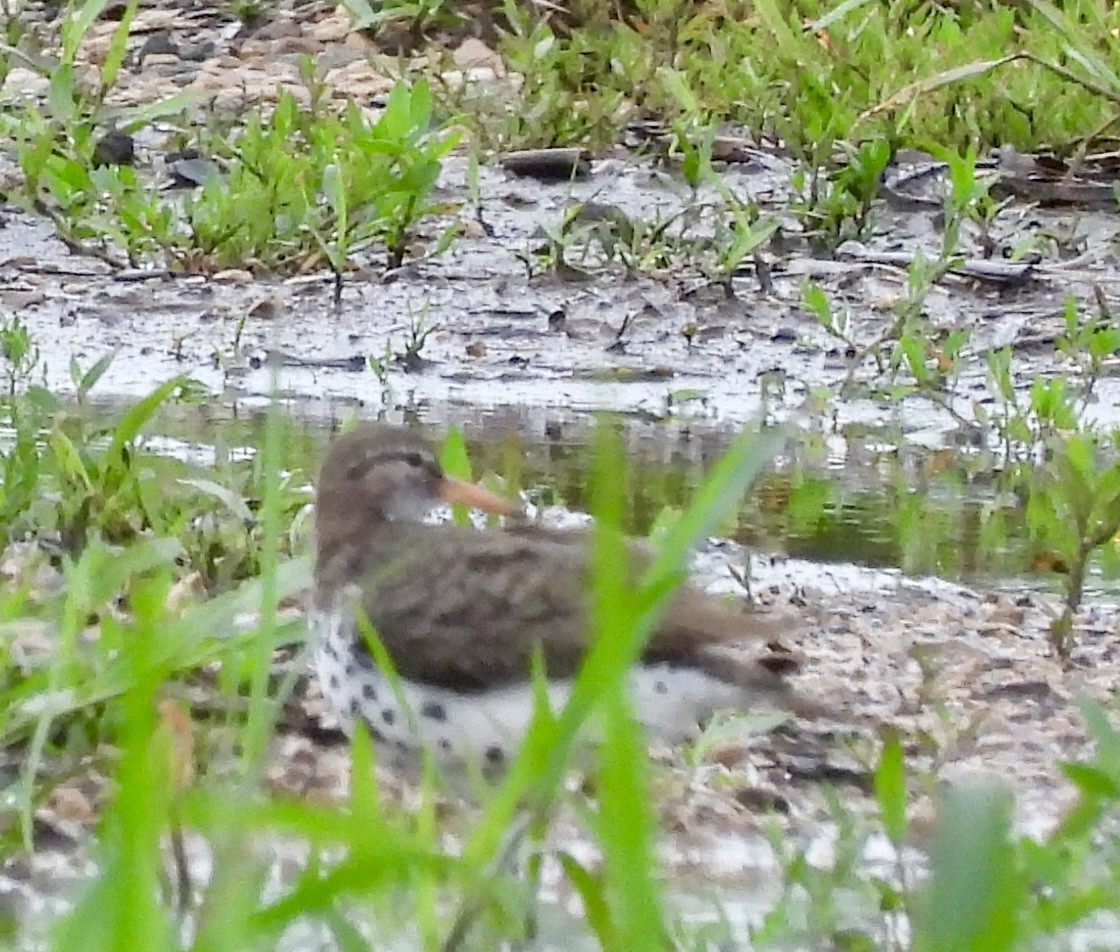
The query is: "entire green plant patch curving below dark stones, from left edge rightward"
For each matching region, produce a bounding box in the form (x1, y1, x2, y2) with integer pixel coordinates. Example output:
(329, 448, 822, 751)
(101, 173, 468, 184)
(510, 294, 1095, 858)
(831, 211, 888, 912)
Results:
(0, 59, 458, 277)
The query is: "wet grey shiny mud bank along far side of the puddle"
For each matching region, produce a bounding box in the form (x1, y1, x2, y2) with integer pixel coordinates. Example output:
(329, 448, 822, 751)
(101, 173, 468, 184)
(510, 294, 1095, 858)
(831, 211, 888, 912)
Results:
(0, 148, 1120, 436)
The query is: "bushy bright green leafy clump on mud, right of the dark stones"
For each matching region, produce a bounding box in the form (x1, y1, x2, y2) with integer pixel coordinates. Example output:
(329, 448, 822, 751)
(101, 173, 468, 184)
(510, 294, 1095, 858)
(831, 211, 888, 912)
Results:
(184, 76, 457, 274)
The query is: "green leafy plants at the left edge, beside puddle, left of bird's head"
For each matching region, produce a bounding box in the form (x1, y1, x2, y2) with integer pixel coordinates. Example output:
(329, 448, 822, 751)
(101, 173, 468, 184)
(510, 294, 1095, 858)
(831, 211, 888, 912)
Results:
(0, 371, 307, 592)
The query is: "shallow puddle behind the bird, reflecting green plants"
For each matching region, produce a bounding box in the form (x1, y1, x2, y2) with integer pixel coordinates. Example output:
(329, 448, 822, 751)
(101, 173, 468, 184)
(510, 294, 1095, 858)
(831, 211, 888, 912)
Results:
(56, 401, 1070, 595)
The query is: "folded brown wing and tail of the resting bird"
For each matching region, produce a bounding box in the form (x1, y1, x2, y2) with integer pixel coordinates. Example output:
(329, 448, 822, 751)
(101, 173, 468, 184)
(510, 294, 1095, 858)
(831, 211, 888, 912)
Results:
(353, 524, 796, 691)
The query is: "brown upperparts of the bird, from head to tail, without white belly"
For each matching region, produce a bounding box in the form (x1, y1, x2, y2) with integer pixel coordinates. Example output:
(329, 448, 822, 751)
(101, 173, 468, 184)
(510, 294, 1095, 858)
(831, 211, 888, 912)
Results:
(316, 424, 797, 700)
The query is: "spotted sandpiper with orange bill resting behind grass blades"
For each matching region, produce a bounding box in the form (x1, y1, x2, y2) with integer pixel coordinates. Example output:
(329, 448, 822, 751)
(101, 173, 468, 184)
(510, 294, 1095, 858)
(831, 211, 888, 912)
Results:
(309, 423, 799, 777)
